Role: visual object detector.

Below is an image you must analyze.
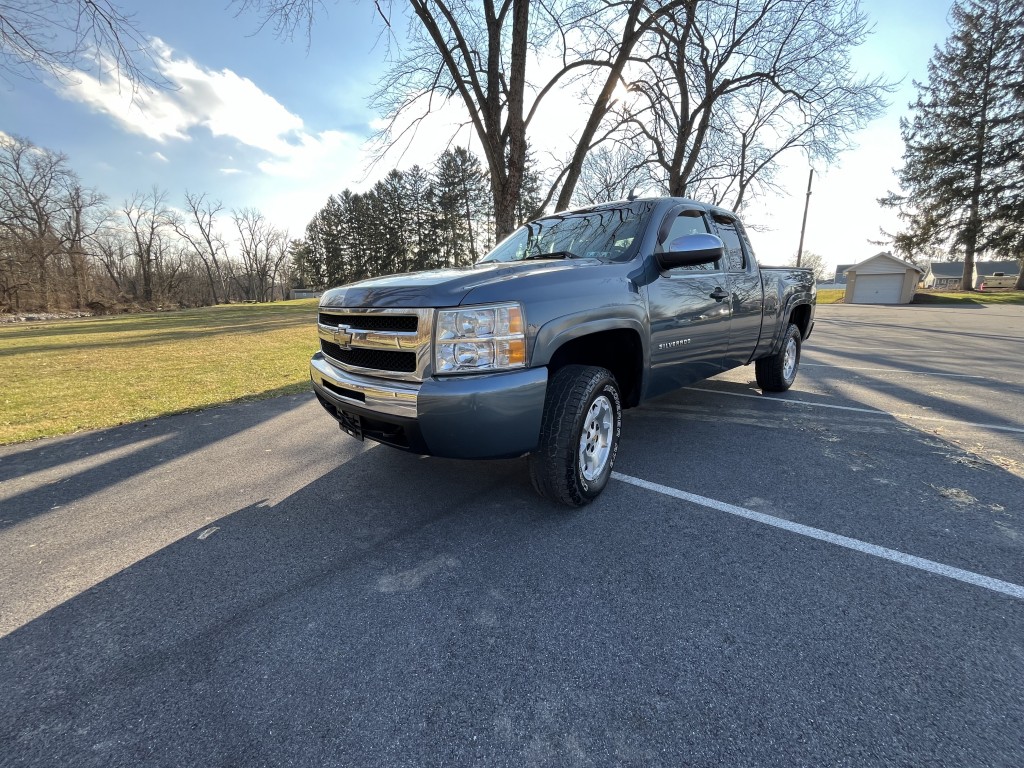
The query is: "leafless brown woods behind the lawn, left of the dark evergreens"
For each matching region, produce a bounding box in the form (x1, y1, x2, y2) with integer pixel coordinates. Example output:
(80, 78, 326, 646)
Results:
(0, 133, 292, 313)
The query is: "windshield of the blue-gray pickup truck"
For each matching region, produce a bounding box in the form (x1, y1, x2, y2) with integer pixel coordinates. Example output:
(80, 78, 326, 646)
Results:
(479, 203, 653, 264)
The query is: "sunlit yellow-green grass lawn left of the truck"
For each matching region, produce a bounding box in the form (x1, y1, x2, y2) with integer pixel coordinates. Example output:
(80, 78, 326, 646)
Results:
(0, 299, 317, 444)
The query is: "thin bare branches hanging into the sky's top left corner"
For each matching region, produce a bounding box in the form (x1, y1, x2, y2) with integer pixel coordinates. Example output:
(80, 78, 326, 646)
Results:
(0, 0, 161, 89)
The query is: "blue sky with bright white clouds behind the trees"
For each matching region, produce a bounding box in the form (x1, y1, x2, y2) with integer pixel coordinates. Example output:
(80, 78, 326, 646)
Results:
(0, 0, 949, 272)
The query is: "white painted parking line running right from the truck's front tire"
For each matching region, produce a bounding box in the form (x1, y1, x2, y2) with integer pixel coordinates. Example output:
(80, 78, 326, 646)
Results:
(611, 472, 1024, 600)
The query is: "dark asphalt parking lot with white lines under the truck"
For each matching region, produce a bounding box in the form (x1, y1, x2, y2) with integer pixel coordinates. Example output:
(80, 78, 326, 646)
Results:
(0, 306, 1024, 766)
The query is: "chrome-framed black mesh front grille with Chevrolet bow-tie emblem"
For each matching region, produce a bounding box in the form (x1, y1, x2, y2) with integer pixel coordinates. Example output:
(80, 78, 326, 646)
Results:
(317, 307, 434, 381)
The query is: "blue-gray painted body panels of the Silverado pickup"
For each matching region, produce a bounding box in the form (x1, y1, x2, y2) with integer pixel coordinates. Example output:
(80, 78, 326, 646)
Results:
(311, 198, 814, 458)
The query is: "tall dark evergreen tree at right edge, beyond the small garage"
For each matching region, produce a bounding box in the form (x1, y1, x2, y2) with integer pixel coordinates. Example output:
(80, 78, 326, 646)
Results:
(880, 0, 1024, 290)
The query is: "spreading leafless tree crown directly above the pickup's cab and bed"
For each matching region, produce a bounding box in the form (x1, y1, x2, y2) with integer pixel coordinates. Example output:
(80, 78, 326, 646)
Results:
(616, 0, 891, 209)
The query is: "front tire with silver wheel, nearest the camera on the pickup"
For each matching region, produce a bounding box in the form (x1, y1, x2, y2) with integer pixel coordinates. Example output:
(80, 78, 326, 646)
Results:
(529, 366, 623, 507)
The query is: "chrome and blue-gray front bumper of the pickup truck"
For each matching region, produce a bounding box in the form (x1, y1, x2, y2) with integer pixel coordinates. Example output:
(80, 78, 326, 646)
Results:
(309, 352, 548, 459)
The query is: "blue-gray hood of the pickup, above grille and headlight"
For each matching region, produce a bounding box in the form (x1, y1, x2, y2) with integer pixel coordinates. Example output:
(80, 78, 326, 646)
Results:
(321, 259, 605, 307)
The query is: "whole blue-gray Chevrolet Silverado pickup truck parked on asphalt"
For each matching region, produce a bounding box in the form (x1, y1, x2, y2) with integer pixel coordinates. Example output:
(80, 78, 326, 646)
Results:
(310, 198, 815, 506)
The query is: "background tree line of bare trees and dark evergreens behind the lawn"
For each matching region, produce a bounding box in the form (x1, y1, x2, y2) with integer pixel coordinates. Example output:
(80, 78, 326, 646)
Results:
(0, 133, 542, 313)
